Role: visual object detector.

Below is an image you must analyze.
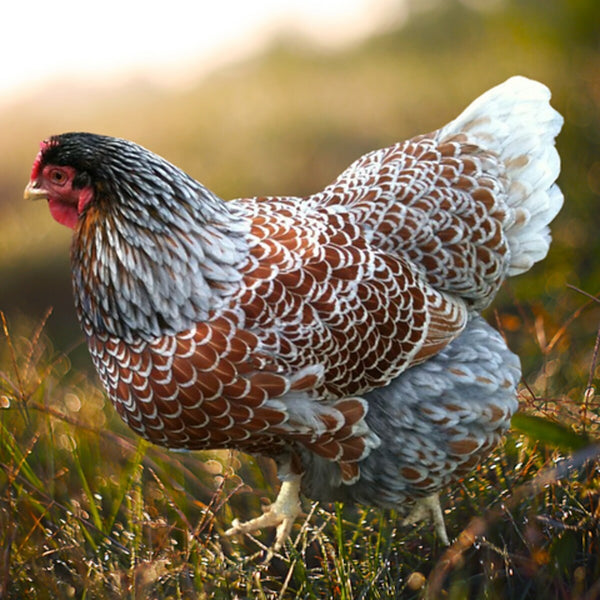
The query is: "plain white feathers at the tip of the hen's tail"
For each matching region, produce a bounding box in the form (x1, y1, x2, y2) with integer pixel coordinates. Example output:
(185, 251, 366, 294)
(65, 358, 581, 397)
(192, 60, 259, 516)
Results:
(438, 77, 563, 275)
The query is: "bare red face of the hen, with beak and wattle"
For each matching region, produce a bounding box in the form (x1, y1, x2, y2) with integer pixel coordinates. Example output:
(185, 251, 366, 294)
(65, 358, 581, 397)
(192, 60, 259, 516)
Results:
(25, 152, 94, 229)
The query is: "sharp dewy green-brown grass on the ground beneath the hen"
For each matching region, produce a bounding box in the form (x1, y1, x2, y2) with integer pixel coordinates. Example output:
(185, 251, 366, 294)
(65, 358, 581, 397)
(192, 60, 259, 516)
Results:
(0, 292, 600, 600)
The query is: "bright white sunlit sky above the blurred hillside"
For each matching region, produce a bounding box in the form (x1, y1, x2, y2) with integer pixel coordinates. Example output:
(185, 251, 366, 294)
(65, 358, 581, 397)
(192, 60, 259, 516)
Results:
(0, 0, 404, 98)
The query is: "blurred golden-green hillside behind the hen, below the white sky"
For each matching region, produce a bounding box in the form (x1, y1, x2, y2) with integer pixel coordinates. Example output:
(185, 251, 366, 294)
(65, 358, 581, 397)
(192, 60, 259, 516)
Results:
(0, 2, 600, 356)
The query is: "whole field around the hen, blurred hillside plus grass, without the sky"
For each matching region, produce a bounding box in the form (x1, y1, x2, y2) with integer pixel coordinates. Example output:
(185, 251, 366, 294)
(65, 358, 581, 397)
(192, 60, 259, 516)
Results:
(0, 0, 600, 600)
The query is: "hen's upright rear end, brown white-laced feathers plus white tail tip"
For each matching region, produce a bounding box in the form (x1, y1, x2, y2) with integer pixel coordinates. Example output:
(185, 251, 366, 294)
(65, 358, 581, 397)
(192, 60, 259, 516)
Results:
(308, 77, 563, 310)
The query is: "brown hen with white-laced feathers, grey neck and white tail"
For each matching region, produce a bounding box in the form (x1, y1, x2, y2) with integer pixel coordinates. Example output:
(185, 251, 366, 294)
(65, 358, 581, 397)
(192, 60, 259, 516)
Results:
(25, 77, 563, 549)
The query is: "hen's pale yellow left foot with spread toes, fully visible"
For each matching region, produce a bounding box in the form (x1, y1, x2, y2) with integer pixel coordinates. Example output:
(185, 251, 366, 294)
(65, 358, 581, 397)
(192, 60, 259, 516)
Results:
(225, 477, 302, 561)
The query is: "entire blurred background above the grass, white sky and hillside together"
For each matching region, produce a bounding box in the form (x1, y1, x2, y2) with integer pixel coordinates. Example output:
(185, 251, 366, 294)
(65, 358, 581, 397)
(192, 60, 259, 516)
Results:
(0, 0, 600, 372)
